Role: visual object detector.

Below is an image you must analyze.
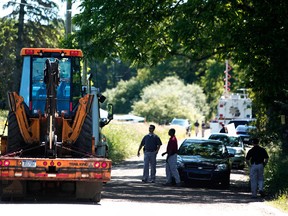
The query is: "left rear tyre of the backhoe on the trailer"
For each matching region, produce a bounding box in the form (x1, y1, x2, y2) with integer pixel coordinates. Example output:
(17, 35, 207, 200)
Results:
(7, 112, 26, 153)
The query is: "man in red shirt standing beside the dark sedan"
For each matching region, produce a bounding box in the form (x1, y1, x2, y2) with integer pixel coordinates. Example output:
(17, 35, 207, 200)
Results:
(162, 128, 181, 186)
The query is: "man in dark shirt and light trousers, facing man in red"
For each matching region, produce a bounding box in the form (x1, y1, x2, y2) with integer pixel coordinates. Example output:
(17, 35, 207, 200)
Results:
(137, 125, 162, 183)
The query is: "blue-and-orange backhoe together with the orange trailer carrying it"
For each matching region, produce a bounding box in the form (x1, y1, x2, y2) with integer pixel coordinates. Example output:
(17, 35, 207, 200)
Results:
(0, 48, 113, 202)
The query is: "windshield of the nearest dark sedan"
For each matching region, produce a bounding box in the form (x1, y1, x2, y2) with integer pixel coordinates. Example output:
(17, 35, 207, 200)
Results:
(178, 141, 225, 158)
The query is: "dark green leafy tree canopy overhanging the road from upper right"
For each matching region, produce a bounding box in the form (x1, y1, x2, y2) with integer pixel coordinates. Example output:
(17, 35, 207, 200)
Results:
(75, 0, 288, 146)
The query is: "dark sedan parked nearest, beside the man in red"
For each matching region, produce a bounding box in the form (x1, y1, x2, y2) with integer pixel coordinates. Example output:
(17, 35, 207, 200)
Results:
(177, 139, 231, 188)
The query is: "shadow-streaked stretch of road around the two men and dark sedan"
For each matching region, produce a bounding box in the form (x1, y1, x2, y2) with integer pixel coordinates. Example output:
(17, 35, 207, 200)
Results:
(102, 159, 263, 204)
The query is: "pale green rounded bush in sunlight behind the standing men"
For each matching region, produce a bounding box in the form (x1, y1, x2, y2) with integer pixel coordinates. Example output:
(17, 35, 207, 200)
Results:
(132, 77, 208, 124)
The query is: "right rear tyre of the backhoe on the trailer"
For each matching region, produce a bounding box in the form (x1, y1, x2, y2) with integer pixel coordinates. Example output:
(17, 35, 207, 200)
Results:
(73, 114, 92, 157)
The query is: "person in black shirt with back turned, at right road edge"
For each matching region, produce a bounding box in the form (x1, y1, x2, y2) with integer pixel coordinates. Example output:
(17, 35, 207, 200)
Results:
(246, 138, 269, 198)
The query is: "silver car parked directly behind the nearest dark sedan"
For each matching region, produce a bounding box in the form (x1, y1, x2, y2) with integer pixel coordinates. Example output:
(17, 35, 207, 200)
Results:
(208, 133, 246, 169)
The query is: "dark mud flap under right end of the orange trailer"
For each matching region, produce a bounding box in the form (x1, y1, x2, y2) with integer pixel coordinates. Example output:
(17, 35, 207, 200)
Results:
(76, 182, 103, 203)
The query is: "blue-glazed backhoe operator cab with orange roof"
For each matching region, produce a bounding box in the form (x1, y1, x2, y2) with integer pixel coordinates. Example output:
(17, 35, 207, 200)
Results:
(20, 49, 83, 115)
